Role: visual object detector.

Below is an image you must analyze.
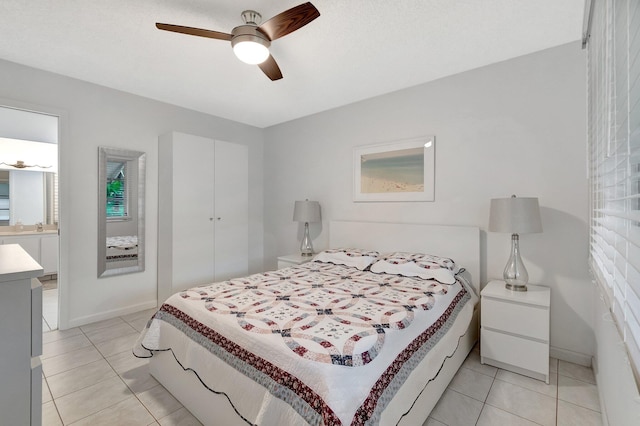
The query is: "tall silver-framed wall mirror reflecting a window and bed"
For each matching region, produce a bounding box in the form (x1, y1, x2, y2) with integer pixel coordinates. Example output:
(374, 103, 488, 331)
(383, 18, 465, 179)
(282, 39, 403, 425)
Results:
(98, 147, 145, 278)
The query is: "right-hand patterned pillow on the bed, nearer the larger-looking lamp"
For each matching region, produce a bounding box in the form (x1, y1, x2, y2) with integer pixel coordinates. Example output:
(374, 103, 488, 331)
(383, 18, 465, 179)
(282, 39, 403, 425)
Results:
(371, 252, 458, 284)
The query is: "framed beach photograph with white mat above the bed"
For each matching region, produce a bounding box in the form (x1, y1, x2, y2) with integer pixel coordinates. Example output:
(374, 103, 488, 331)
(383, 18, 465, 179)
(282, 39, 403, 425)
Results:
(353, 135, 436, 201)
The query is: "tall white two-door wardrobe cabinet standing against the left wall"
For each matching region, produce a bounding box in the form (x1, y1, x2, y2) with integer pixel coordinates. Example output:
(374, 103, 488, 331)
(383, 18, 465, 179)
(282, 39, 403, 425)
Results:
(158, 132, 249, 302)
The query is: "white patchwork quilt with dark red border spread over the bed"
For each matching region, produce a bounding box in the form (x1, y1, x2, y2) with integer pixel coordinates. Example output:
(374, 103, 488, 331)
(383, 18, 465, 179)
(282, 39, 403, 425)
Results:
(134, 262, 477, 425)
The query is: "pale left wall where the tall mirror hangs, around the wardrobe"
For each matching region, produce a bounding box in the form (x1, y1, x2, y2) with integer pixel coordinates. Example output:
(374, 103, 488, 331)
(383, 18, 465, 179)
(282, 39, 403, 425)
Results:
(0, 61, 263, 328)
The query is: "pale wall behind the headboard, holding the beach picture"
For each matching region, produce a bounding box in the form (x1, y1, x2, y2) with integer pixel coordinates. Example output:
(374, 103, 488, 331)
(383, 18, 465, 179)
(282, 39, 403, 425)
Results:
(265, 43, 594, 364)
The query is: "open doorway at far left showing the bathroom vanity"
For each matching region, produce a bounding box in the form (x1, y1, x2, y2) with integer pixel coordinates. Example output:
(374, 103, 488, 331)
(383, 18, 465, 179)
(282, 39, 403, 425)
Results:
(0, 100, 60, 331)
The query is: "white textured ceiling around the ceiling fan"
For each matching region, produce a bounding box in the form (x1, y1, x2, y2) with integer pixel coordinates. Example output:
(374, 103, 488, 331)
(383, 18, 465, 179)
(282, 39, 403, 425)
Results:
(0, 0, 584, 127)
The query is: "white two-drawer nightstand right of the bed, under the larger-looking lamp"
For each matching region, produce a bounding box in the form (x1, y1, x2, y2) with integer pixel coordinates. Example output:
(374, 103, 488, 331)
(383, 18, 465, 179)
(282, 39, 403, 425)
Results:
(480, 280, 551, 384)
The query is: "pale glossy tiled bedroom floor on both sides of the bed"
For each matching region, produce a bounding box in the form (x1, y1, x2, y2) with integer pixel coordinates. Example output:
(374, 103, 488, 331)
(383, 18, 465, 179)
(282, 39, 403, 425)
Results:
(42, 310, 601, 426)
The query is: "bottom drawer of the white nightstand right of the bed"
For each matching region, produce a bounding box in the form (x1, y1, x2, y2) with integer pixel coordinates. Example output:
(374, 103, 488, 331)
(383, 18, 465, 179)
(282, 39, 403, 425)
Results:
(480, 328, 549, 376)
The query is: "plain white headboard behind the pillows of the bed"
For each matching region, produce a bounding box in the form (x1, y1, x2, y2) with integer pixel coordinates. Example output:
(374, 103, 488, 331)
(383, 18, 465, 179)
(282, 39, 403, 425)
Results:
(329, 221, 480, 294)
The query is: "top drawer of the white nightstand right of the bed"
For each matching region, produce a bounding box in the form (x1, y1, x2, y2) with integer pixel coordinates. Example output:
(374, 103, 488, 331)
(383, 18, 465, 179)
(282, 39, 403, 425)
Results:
(481, 297, 549, 341)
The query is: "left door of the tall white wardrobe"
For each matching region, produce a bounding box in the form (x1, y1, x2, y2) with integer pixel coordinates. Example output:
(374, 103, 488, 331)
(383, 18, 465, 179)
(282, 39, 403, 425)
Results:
(172, 133, 215, 292)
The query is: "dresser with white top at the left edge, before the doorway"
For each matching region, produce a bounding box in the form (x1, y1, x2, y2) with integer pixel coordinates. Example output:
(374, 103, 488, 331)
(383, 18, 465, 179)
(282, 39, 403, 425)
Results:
(0, 244, 42, 425)
